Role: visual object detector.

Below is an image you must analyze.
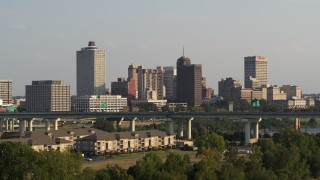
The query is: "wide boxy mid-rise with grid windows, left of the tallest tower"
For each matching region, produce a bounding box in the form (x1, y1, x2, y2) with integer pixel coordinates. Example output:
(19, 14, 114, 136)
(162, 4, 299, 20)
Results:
(26, 80, 71, 112)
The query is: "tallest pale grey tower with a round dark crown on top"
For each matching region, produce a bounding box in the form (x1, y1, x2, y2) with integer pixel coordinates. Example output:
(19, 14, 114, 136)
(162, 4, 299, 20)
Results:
(77, 41, 106, 96)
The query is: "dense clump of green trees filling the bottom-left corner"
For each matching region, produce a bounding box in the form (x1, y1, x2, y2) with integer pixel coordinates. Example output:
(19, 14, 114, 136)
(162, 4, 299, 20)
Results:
(0, 142, 82, 180)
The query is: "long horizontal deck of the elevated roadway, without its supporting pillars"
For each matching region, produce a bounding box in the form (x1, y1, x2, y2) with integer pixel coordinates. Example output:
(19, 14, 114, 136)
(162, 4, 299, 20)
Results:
(0, 112, 320, 119)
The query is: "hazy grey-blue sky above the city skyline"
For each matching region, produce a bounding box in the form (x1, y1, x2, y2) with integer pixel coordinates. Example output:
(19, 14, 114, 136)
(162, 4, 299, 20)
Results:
(0, 0, 320, 96)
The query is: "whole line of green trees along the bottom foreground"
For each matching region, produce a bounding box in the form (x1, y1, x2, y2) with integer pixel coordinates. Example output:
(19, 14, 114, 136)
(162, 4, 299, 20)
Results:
(0, 129, 320, 180)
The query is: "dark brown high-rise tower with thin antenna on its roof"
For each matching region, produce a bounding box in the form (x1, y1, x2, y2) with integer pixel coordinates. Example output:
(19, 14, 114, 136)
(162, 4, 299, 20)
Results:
(176, 56, 202, 107)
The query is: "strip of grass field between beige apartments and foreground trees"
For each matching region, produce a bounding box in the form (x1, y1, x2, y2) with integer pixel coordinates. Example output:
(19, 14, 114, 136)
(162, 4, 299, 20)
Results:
(82, 149, 200, 170)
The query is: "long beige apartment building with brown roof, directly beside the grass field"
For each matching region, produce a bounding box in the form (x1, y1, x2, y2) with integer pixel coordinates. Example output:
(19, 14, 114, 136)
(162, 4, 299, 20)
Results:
(75, 130, 175, 155)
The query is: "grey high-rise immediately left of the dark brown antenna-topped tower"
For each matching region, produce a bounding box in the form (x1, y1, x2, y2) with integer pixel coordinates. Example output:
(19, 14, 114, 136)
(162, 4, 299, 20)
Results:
(163, 66, 177, 102)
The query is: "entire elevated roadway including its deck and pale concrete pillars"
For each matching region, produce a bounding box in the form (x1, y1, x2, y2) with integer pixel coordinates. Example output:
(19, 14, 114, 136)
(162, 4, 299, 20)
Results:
(0, 112, 320, 144)
